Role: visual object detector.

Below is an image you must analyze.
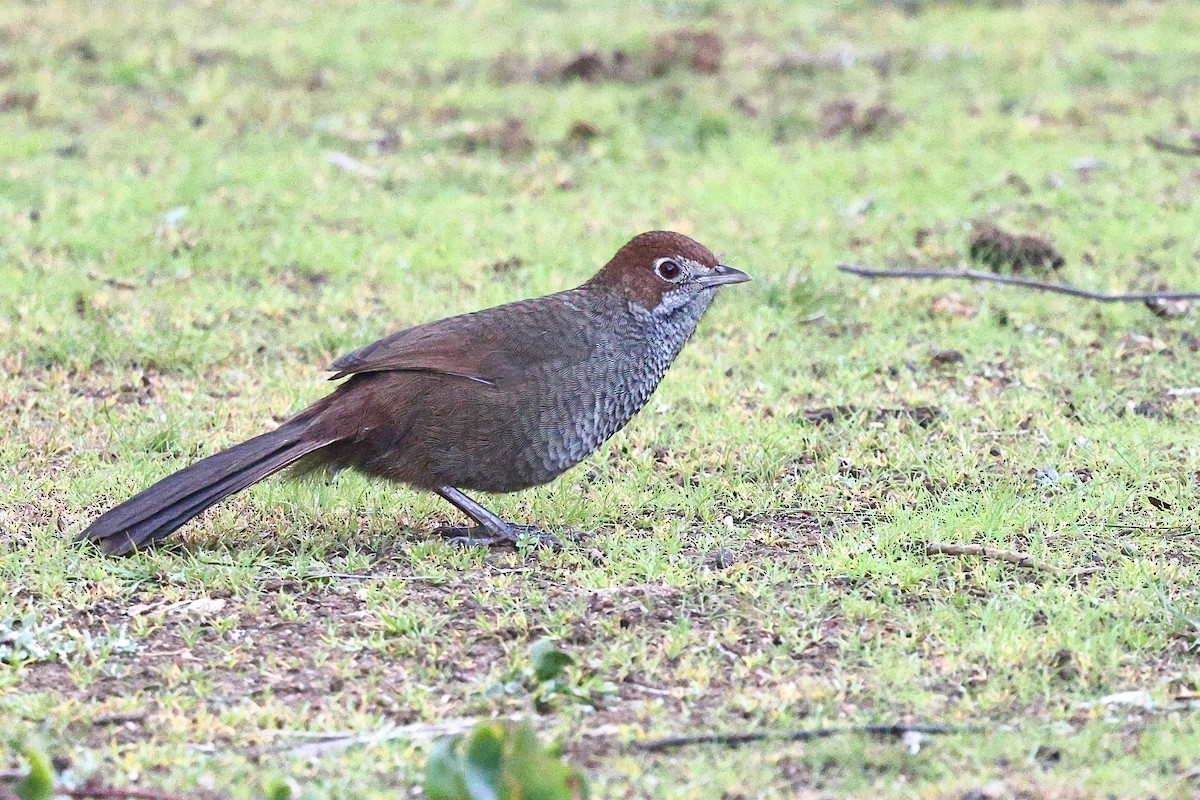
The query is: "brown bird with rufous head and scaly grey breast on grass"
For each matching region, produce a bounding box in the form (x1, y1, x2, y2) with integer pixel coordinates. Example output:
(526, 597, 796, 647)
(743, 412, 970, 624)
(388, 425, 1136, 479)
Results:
(77, 230, 750, 555)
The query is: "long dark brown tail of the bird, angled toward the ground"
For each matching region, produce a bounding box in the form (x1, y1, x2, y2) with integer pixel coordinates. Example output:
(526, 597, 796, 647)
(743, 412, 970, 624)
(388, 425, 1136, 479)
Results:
(78, 420, 334, 555)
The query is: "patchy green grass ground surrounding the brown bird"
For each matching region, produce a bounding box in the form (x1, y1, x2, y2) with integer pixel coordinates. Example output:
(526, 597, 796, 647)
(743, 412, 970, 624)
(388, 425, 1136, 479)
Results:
(0, 0, 1200, 798)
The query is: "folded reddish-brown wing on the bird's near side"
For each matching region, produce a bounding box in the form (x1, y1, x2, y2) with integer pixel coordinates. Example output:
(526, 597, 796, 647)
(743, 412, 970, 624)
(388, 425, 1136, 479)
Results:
(329, 299, 582, 385)
